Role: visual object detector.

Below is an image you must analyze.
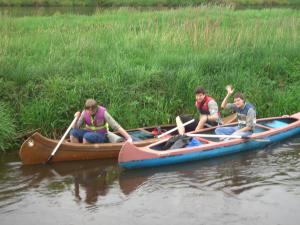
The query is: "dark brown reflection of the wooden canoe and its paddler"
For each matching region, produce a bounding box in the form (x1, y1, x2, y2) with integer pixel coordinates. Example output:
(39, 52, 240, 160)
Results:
(21, 159, 119, 204)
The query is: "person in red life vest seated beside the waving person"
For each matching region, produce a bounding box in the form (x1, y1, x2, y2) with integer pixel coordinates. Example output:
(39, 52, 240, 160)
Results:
(176, 87, 222, 134)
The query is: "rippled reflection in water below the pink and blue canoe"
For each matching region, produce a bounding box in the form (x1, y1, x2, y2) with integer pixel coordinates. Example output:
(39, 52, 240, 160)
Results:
(119, 138, 300, 195)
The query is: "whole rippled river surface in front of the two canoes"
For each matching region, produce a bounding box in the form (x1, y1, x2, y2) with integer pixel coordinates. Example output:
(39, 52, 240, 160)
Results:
(0, 137, 300, 225)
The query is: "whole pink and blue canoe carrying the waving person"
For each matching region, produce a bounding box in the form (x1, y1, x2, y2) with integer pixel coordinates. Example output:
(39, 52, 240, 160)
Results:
(118, 112, 300, 169)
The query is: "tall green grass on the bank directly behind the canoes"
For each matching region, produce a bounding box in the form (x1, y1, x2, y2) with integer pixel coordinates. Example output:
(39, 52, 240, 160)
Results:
(0, 7, 300, 148)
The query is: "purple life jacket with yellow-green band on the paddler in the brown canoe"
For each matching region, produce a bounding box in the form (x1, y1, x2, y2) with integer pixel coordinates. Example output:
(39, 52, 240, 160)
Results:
(84, 106, 108, 133)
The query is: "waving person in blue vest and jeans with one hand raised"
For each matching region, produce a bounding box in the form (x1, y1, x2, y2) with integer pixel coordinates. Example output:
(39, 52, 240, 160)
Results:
(215, 85, 256, 136)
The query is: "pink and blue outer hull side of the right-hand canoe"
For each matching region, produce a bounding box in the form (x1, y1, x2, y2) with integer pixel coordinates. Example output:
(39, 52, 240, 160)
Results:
(119, 114, 300, 169)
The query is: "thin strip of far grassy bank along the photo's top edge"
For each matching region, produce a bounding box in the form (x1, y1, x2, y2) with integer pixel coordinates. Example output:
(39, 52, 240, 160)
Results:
(0, 0, 300, 7)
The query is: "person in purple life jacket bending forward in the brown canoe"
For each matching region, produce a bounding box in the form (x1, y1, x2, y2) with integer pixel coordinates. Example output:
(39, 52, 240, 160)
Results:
(70, 99, 132, 144)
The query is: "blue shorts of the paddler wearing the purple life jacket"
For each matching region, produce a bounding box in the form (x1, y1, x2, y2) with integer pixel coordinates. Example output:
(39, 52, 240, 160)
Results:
(70, 128, 107, 143)
